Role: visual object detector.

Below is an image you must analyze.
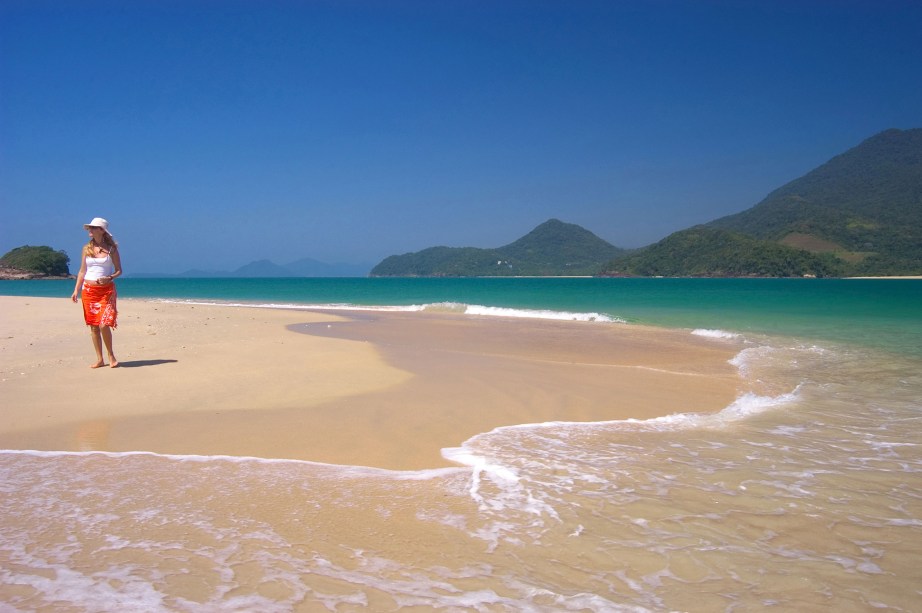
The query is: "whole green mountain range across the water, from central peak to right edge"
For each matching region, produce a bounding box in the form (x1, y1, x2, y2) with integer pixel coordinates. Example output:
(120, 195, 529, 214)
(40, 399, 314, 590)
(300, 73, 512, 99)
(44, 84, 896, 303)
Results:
(371, 129, 922, 277)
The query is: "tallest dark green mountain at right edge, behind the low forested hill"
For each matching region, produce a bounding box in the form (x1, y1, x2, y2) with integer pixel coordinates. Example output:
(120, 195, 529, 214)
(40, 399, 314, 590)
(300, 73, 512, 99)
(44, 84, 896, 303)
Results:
(708, 129, 922, 274)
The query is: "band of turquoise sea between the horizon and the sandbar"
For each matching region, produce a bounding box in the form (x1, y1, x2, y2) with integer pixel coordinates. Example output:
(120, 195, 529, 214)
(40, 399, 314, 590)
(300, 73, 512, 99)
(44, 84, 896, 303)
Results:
(0, 278, 922, 355)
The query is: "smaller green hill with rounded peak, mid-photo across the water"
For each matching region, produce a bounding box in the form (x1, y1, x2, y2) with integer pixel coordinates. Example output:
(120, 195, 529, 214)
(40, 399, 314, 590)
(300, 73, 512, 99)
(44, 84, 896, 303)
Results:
(371, 219, 623, 277)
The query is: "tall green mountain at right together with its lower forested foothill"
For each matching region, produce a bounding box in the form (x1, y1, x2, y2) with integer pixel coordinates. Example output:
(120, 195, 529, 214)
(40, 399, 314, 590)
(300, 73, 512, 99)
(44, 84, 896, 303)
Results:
(602, 129, 922, 276)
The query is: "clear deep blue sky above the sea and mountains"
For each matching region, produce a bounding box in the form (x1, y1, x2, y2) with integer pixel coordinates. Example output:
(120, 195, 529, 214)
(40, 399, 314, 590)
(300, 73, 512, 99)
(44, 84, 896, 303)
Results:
(0, 0, 922, 273)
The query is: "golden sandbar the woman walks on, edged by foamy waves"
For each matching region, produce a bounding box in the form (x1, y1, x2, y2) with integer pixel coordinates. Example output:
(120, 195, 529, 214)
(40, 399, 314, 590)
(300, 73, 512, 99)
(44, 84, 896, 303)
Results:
(0, 296, 741, 469)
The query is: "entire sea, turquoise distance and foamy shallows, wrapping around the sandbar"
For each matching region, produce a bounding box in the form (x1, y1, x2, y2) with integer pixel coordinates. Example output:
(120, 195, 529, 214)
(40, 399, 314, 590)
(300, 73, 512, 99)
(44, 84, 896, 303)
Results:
(0, 278, 922, 612)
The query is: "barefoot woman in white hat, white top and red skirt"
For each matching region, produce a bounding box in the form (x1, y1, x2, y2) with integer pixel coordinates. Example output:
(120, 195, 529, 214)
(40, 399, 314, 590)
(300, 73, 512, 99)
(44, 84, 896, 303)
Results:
(70, 217, 122, 368)
